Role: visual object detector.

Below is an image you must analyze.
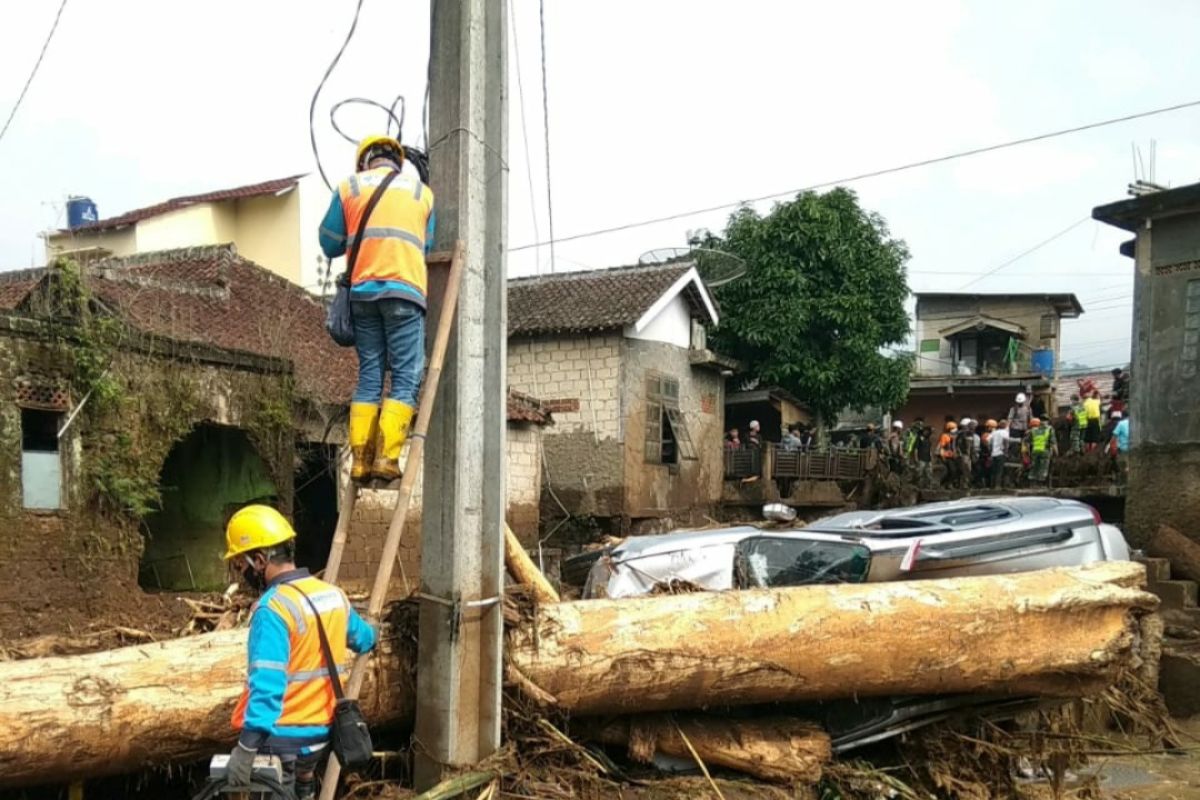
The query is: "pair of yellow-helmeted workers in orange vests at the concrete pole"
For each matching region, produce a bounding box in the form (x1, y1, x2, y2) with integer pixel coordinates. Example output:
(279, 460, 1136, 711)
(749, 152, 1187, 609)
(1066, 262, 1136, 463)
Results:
(217, 136, 434, 800)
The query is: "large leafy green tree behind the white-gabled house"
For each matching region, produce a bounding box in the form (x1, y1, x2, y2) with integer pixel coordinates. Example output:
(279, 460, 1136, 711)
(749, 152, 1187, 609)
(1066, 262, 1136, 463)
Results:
(694, 188, 911, 422)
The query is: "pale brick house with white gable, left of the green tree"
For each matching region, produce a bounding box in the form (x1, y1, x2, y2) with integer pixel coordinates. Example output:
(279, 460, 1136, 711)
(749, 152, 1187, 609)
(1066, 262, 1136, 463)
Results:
(508, 264, 732, 529)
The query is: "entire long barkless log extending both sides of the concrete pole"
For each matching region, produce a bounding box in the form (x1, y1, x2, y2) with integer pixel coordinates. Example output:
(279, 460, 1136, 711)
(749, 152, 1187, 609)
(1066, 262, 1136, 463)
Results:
(0, 563, 1158, 788)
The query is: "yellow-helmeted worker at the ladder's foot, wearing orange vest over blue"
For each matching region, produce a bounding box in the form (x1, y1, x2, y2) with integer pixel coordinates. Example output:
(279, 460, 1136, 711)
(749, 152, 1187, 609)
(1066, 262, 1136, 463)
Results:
(224, 505, 376, 800)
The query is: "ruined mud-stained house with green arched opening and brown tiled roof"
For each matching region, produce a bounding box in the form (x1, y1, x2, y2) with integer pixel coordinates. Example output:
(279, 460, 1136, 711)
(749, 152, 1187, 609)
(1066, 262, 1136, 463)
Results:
(0, 245, 551, 636)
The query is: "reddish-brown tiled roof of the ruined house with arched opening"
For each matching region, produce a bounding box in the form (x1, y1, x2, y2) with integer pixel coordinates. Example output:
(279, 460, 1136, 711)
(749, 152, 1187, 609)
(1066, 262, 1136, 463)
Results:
(0, 245, 358, 404)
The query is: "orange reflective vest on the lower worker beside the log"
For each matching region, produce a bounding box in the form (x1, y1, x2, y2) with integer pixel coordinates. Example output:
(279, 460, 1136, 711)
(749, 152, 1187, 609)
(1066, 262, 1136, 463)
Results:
(233, 576, 350, 734)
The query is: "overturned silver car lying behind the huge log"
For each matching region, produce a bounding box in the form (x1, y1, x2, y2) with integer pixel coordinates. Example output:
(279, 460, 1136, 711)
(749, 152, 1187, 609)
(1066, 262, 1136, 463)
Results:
(577, 497, 1129, 597)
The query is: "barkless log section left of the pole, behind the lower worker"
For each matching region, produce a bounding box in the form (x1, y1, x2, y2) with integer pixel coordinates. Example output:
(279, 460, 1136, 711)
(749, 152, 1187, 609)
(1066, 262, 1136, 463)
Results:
(0, 630, 413, 788)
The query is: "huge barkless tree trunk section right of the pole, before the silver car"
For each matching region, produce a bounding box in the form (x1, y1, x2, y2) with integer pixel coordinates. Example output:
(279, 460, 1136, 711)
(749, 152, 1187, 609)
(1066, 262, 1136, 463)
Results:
(509, 561, 1158, 715)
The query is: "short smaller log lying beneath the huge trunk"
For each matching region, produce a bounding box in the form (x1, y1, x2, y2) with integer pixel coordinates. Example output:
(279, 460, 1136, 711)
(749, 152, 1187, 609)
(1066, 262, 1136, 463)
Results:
(586, 714, 833, 783)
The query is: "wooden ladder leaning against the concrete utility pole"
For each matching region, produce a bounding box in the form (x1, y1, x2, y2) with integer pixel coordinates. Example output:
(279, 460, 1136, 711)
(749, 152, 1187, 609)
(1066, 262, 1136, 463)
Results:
(320, 241, 463, 800)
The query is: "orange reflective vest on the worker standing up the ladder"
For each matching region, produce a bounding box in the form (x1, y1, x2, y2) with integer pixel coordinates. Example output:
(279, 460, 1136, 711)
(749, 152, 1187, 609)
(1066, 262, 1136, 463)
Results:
(337, 167, 433, 307)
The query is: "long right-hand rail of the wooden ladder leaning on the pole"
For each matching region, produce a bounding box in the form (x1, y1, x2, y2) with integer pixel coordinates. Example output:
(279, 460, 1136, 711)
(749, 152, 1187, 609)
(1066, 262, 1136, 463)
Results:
(320, 240, 463, 800)
